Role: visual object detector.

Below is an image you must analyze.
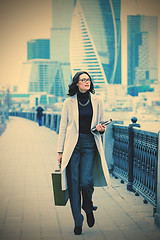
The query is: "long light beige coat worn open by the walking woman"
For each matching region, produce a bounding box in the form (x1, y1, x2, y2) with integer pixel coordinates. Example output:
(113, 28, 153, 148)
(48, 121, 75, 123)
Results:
(57, 93, 110, 190)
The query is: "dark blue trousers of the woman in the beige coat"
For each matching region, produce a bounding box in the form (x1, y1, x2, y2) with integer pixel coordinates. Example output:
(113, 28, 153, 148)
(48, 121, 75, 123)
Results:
(66, 133, 97, 226)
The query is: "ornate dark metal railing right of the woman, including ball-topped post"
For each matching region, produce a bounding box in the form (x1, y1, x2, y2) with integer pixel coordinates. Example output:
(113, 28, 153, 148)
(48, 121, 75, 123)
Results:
(113, 120, 158, 207)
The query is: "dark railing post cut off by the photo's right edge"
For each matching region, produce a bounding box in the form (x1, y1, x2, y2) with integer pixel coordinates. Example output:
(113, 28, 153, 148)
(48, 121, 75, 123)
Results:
(154, 131, 160, 228)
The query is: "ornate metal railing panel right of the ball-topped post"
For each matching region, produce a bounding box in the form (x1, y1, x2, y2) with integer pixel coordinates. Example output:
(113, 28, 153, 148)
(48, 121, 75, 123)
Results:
(133, 129, 158, 206)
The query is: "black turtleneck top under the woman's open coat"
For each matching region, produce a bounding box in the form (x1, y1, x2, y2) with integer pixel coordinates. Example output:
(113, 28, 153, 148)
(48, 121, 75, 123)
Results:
(77, 91, 93, 134)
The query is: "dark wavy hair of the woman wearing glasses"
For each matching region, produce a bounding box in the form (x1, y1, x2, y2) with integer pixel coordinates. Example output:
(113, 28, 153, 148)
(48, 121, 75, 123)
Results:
(67, 71, 95, 96)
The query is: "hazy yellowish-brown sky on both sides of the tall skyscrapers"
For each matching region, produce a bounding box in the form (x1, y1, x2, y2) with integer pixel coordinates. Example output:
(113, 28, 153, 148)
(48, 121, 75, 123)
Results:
(0, 0, 160, 90)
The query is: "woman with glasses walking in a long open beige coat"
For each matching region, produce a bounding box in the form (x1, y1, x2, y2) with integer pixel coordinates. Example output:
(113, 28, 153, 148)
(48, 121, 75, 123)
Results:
(57, 71, 109, 235)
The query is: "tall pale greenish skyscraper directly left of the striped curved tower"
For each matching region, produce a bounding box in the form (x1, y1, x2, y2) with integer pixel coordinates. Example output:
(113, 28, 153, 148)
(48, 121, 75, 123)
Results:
(50, 0, 74, 94)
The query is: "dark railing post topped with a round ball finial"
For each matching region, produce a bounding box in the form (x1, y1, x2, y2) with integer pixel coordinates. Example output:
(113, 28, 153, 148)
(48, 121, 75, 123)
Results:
(127, 117, 140, 191)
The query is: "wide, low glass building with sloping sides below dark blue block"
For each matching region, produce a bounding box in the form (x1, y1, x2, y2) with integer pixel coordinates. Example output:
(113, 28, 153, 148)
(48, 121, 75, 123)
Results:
(18, 59, 64, 97)
